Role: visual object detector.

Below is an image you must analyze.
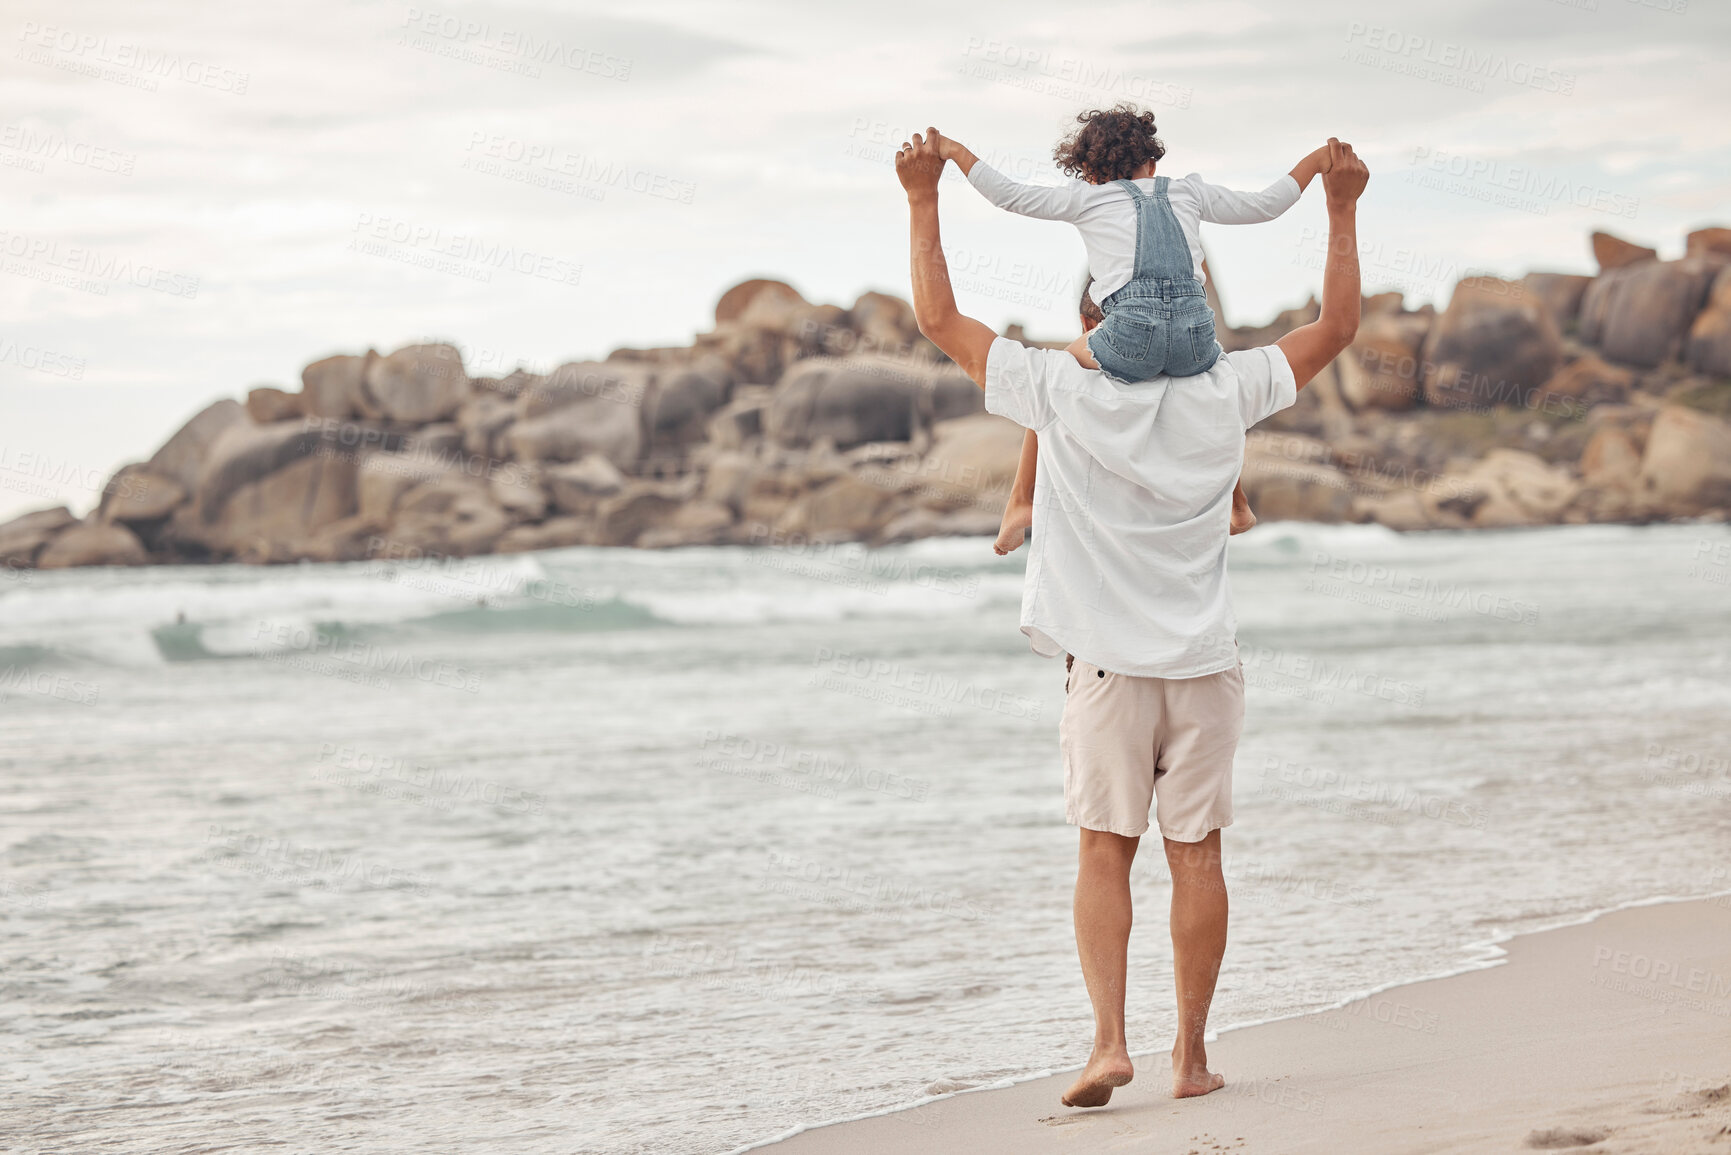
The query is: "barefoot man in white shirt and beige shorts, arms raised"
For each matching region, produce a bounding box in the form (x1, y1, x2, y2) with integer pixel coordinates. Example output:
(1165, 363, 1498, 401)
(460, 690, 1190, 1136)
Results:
(895, 128, 1369, 1107)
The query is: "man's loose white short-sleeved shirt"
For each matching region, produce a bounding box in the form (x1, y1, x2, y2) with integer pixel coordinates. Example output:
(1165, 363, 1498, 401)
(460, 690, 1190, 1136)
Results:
(985, 338, 1298, 677)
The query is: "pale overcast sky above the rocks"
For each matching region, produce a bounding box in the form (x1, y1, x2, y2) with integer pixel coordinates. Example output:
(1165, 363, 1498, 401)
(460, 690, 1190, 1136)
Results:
(0, 0, 1731, 513)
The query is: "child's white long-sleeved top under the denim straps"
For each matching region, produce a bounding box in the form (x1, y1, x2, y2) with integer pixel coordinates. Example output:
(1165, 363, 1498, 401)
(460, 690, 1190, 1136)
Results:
(968, 161, 1302, 305)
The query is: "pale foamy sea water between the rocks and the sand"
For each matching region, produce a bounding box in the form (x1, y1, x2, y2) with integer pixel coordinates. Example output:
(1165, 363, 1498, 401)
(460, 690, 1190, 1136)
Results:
(0, 525, 1731, 1153)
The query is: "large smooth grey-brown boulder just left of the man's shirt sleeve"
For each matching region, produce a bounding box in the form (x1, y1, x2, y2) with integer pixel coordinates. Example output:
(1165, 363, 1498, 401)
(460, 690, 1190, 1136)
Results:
(765, 357, 928, 448)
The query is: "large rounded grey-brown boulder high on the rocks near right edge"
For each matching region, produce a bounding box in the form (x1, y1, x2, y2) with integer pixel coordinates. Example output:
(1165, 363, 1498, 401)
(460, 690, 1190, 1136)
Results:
(1580, 256, 1722, 369)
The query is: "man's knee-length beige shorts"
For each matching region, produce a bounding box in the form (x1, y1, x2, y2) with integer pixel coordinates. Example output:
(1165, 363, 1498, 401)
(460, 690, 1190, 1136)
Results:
(1058, 660, 1245, 842)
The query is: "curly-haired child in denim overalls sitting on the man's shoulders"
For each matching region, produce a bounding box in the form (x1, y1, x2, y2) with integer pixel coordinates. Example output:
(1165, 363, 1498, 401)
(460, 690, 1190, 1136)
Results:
(938, 104, 1328, 554)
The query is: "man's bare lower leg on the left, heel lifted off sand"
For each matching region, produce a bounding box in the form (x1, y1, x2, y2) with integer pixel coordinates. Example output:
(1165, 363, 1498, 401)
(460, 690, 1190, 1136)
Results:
(1063, 828, 1142, 1107)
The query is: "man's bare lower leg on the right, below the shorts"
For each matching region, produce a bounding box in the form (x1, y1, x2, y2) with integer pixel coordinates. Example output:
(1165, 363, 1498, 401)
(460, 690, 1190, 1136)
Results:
(1163, 829, 1226, 1100)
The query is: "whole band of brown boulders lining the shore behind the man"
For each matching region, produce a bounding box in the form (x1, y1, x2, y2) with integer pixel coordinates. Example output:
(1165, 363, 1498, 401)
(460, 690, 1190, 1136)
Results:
(0, 219, 1731, 566)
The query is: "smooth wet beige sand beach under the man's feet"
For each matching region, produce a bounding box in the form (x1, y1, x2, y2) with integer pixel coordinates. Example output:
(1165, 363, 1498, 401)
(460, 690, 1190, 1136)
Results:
(763, 897, 1731, 1155)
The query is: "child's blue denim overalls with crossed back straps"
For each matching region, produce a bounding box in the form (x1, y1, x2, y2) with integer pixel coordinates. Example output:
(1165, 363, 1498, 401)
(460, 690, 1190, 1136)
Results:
(1087, 177, 1220, 383)
